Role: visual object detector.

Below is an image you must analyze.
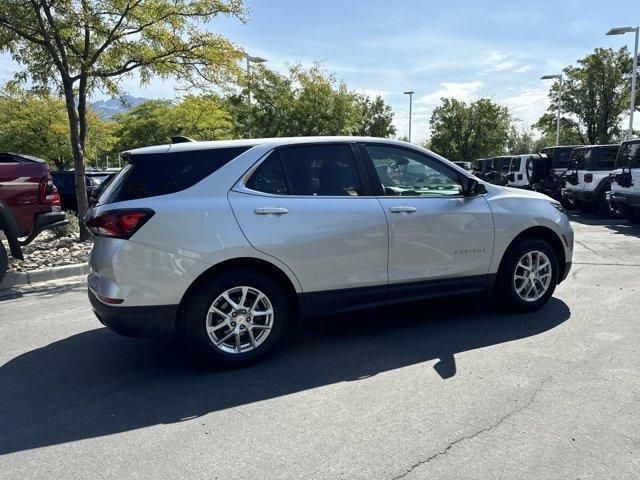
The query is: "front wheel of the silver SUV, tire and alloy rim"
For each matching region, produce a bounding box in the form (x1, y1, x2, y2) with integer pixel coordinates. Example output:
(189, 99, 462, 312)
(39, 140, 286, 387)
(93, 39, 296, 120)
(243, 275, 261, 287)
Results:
(495, 239, 558, 312)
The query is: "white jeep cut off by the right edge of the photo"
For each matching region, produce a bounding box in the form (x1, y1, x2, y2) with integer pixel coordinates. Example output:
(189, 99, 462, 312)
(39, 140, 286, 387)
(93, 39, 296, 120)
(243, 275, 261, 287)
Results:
(606, 139, 640, 224)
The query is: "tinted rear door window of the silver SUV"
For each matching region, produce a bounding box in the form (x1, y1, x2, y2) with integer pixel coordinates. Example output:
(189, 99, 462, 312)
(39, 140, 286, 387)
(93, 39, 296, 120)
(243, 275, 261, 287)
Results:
(246, 145, 363, 197)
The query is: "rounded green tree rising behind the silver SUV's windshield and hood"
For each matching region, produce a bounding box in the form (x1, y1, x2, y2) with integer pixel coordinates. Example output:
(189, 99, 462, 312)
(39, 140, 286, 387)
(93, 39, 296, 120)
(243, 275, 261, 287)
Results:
(429, 98, 511, 162)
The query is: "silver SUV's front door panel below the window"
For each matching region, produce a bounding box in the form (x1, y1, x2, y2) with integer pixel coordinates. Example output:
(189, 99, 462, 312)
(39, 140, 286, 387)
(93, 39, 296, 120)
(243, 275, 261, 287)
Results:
(380, 196, 494, 284)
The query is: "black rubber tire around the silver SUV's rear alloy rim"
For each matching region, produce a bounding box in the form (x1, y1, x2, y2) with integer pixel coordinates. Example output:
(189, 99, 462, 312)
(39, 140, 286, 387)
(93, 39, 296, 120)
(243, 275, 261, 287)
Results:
(181, 269, 291, 366)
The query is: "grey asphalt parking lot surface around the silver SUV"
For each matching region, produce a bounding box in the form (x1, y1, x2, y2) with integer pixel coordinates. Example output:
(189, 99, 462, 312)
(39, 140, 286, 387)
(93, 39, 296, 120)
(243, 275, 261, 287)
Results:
(0, 215, 640, 480)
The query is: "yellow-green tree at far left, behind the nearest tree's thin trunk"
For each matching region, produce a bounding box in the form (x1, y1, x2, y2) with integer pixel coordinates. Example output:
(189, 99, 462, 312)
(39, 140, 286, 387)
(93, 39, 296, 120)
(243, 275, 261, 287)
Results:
(0, 86, 113, 170)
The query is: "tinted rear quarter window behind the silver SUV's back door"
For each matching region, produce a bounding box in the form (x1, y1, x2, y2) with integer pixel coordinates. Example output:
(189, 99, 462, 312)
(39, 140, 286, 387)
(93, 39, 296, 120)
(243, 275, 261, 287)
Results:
(98, 146, 251, 205)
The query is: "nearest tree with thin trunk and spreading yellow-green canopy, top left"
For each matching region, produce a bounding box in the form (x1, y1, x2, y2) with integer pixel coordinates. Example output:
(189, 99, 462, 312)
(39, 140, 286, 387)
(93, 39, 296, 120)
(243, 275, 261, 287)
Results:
(0, 0, 244, 237)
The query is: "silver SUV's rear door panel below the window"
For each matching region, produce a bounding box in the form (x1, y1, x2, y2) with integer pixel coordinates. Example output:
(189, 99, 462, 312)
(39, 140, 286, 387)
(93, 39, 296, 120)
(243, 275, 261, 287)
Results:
(229, 191, 388, 292)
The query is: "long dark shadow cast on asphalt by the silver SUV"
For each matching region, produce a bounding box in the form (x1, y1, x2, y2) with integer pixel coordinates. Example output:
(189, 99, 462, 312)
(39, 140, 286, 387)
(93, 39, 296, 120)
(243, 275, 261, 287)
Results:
(0, 297, 570, 455)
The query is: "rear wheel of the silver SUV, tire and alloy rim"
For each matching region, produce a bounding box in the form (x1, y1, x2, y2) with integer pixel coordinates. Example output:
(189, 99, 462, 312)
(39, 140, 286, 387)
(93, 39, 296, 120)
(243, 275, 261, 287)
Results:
(183, 270, 290, 365)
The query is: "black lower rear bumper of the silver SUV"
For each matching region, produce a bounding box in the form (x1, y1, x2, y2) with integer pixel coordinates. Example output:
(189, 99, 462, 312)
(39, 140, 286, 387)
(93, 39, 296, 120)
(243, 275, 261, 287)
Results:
(88, 290, 178, 338)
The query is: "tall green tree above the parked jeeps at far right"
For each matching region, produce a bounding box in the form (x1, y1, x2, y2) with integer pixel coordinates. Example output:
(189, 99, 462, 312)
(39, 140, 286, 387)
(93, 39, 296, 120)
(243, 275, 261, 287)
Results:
(535, 47, 640, 144)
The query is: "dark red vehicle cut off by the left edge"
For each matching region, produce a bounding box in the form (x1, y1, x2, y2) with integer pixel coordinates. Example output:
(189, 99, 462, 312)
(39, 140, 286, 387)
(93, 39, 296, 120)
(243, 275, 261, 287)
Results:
(0, 152, 68, 282)
